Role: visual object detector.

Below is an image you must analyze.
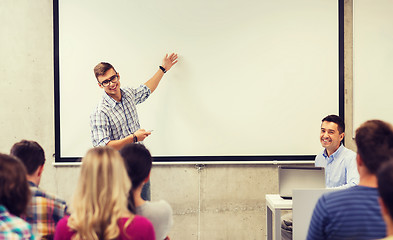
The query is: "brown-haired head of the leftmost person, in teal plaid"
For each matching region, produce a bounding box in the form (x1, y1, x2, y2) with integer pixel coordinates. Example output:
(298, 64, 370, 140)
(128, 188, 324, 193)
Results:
(0, 153, 30, 216)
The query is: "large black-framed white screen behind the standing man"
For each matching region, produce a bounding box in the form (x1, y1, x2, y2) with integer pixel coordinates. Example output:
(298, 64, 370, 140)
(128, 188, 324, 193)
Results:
(56, 0, 339, 158)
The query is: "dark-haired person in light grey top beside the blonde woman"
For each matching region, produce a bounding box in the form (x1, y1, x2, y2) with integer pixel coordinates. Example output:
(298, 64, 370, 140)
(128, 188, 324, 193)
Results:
(120, 144, 173, 240)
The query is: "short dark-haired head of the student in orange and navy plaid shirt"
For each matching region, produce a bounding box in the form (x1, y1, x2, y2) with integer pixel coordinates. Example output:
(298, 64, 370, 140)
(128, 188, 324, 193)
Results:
(11, 140, 45, 175)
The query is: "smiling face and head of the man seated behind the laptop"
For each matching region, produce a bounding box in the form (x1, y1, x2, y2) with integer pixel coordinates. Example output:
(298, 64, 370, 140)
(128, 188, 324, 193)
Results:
(320, 115, 345, 153)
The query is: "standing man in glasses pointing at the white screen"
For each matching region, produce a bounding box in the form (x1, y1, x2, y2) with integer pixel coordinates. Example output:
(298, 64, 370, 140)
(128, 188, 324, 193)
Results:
(90, 53, 177, 200)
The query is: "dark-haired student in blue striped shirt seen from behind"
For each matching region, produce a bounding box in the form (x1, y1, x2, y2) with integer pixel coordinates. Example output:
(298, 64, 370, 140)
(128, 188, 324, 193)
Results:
(307, 120, 393, 240)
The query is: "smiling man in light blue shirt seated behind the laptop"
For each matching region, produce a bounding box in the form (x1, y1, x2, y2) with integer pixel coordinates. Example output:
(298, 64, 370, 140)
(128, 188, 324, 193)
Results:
(281, 115, 359, 239)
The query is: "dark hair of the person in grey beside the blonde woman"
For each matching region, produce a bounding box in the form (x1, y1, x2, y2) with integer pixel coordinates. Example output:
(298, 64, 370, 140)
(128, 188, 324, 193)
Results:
(120, 143, 152, 188)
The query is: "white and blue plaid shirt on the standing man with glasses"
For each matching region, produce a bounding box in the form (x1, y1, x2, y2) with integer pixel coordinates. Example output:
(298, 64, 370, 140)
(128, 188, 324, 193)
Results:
(90, 85, 151, 147)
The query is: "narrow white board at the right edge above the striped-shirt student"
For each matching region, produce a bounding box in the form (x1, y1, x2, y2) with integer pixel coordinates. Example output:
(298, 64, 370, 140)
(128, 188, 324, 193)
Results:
(353, 0, 393, 130)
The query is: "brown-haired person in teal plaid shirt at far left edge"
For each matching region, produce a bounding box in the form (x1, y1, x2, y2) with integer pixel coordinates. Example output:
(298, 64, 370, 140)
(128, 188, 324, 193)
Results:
(0, 153, 35, 239)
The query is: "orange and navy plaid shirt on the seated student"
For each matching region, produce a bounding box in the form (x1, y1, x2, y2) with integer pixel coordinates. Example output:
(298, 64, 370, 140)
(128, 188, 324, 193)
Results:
(23, 182, 68, 239)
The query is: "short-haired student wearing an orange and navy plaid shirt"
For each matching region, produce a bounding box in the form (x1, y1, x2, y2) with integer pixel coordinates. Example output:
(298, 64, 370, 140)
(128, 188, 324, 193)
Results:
(11, 140, 67, 239)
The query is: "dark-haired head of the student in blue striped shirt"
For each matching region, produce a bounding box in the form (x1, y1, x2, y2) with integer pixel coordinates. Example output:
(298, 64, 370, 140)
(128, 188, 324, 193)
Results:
(355, 120, 393, 174)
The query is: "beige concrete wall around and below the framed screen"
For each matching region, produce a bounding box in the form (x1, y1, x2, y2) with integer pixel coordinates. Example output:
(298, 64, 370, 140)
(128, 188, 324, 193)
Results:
(0, 0, 353, 239)
